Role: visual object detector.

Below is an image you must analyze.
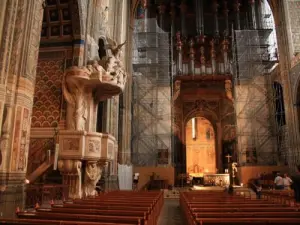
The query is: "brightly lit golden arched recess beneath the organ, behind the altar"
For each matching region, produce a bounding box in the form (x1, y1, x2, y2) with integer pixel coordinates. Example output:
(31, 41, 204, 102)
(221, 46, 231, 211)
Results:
(186, 117, 216, 177)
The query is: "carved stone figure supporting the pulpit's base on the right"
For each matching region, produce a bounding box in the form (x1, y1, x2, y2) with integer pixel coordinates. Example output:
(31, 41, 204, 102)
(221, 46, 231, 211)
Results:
(83, 161, 104, 197)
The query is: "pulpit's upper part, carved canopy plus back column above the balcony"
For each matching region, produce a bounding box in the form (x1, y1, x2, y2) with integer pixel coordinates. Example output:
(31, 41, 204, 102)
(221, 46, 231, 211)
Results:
(62, 39, 127, 131)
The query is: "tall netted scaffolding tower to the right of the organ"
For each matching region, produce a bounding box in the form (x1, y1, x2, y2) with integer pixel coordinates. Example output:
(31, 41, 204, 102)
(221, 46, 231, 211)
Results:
(233, 12, 287, 165)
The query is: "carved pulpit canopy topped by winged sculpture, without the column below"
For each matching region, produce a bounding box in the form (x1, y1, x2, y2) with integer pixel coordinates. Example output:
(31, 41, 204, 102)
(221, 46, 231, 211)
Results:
(63, 39, 127, 101)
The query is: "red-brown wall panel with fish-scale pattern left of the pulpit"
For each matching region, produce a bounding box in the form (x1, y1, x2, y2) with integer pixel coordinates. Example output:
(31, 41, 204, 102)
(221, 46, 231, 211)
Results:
(31, 59, 64, 127)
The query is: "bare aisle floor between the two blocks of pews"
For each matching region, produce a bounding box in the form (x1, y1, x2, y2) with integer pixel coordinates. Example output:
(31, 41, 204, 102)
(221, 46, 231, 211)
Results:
(157, 199, 186, 225)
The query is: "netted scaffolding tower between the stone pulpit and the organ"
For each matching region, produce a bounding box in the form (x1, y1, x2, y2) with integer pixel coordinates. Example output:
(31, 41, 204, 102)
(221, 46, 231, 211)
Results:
(131, 18, 173, 166)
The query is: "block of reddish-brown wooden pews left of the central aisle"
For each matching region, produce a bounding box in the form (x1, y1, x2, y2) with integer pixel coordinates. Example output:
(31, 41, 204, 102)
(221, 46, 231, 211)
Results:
(0, 191, 164, 225)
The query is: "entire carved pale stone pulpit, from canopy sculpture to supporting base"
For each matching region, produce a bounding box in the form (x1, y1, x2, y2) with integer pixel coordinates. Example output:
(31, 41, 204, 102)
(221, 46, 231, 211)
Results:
(58, 38, 127, 198)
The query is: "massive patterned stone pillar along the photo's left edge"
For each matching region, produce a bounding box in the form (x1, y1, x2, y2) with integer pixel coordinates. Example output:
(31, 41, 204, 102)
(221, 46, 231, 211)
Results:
(0, 0, 43, 216)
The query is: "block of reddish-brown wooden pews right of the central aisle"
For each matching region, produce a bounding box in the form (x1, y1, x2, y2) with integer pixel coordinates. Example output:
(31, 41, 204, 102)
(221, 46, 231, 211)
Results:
(180, 191, 300, 225)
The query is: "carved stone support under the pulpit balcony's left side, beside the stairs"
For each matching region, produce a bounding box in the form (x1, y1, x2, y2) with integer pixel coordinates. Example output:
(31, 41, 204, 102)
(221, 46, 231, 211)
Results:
(58, 159, 82, 199)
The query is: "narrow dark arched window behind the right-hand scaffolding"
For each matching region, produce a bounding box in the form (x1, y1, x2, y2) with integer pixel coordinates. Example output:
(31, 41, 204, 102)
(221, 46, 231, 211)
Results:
(273, 82, 286, 126)
